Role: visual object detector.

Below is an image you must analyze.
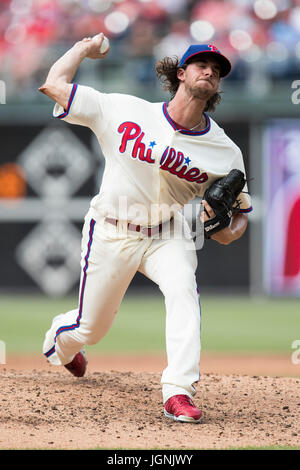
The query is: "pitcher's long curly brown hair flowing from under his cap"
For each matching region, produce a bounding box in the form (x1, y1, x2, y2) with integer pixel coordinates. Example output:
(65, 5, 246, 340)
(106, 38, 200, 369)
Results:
(155, 57, 221, 111)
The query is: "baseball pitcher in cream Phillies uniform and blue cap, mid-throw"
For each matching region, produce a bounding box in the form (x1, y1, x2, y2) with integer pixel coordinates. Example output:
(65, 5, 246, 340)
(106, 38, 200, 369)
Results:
(40, 33, 251, 423)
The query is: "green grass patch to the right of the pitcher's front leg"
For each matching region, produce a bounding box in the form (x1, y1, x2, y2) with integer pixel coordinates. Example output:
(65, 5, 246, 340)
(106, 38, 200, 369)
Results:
(201, 297, 300, 354)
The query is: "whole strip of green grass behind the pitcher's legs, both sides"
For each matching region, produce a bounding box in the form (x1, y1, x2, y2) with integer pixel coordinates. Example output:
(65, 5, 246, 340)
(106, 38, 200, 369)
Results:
(0, 295, 300, 354)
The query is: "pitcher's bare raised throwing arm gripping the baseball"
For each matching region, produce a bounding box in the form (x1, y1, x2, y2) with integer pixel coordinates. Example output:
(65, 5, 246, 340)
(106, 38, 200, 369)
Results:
(39, 33, 109, 109)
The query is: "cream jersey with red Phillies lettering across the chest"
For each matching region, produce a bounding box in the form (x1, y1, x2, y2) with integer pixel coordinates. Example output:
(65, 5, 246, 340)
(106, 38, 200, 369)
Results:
(53, 83, 252, 225)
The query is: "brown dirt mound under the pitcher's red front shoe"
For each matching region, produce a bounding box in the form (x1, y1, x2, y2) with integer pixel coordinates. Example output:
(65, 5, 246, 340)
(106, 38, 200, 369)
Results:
(0, 366, 300, 449)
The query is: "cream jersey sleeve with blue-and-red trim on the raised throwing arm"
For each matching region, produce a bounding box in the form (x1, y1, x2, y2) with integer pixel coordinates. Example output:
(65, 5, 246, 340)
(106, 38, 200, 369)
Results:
(53, 83, 109, 135)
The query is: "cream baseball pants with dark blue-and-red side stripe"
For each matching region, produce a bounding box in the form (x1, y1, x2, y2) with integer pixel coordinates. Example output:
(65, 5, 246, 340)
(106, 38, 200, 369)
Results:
(43, 210, 201, 403)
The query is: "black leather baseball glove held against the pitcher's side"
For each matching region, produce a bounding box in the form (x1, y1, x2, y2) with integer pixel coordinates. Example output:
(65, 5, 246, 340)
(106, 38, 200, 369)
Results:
(203, 170, 246, 239)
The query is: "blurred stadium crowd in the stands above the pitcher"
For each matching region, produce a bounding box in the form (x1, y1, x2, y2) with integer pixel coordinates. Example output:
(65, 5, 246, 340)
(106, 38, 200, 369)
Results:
(0, 0, 300, 98)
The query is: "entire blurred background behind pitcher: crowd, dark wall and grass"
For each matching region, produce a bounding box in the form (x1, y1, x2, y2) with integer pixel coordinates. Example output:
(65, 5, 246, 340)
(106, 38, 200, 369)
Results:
(0, 0, 300, 374)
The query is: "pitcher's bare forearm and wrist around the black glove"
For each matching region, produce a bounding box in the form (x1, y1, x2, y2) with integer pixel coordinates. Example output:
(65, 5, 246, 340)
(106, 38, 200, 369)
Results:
(201, 200, 248, 245)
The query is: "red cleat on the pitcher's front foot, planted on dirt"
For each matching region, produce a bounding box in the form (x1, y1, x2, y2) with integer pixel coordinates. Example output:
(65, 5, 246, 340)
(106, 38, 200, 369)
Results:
(164, 395, 202, 423)
